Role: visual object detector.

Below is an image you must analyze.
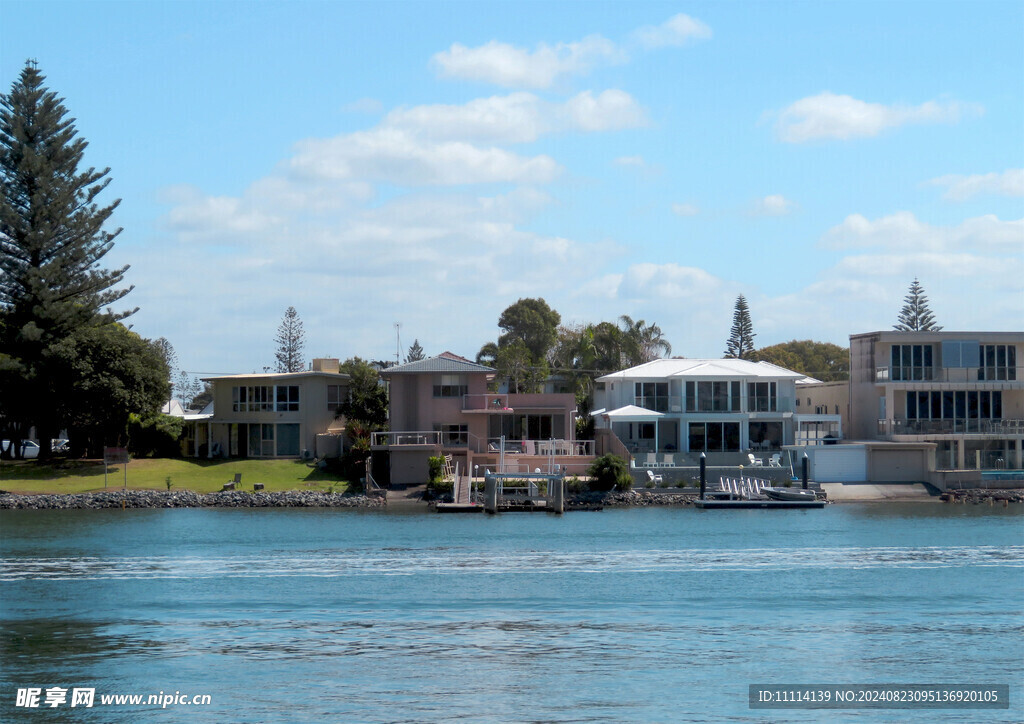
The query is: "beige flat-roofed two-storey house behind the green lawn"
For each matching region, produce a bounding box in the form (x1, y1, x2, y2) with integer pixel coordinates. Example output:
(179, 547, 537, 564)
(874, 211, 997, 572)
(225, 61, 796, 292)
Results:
(193, 358, 348, 458)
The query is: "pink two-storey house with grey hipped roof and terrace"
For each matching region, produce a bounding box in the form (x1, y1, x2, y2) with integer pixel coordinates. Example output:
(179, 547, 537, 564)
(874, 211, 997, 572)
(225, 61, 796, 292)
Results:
(373, 352, 594, 484)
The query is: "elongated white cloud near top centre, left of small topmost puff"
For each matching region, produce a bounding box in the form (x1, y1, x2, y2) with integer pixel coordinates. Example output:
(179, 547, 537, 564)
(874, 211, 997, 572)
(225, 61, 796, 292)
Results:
(431, 35, 625, 88)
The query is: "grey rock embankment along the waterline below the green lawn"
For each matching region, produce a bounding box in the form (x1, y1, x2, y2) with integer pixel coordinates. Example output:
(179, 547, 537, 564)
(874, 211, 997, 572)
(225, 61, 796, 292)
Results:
(0, 491, 386, 510)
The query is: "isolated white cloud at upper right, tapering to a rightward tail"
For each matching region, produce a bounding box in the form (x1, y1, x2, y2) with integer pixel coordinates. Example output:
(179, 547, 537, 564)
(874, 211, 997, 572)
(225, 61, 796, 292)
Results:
(775, 91, 977, 143)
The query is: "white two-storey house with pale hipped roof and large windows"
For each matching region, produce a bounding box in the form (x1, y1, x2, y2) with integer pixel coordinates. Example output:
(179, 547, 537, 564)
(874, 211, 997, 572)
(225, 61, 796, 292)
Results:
(594, 359, 843, 464)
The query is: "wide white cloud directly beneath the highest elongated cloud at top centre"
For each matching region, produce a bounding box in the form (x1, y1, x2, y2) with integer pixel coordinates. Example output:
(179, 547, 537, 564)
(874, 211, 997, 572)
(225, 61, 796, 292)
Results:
(381, 89, 647, 142)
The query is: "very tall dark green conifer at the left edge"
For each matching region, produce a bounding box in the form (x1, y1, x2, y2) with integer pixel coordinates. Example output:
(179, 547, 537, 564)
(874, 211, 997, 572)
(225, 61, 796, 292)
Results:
(0, 61, 134, 458)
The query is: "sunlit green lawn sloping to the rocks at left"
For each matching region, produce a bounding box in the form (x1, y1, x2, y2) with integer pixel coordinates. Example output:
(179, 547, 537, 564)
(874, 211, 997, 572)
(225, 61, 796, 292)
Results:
(0, 458, 354, 494)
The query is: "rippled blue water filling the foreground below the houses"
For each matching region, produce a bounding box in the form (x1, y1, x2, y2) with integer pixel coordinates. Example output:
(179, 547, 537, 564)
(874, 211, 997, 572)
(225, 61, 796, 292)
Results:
(0, 504, 1024, 722)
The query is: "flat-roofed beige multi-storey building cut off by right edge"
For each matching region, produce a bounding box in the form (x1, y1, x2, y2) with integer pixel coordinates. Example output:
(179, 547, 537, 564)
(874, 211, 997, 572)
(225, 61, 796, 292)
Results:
(850, 331, 1024, 470)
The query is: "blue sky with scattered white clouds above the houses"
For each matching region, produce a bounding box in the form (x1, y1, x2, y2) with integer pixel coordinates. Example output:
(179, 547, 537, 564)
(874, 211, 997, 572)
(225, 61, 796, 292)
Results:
(0, 0, 1024, 373)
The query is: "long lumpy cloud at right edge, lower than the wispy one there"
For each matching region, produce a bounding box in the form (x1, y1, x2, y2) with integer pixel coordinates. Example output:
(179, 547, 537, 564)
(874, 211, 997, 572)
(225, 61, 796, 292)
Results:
(821, 211, 1024, 253)
